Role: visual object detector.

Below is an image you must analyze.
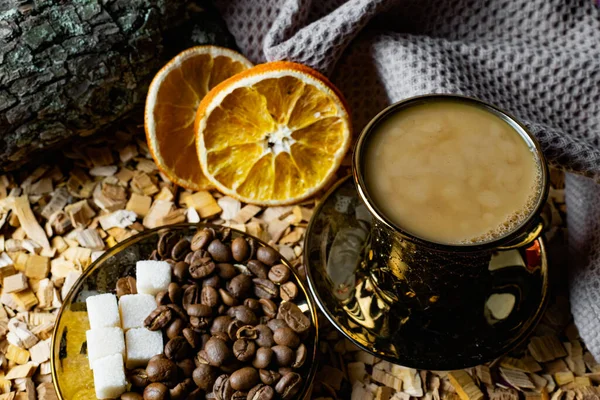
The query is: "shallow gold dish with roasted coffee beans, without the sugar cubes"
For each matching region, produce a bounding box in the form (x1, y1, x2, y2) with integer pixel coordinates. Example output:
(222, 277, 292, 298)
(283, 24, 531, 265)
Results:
(51, 224, 318, 400)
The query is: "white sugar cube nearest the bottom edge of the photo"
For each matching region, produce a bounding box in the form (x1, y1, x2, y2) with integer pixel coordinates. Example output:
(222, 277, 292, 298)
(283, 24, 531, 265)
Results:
(94, 354, 127, 399)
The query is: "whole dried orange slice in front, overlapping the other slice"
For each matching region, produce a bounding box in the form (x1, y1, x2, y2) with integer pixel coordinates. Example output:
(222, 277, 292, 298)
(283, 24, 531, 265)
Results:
(195, 61, 351, 205)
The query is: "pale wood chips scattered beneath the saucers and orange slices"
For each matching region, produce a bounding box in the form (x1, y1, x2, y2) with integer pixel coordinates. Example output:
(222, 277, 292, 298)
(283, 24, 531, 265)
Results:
(0, 126, 600, 400)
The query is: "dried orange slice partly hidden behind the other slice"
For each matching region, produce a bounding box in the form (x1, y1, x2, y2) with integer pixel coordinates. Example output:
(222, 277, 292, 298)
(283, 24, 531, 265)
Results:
(144, 46, 252, 190)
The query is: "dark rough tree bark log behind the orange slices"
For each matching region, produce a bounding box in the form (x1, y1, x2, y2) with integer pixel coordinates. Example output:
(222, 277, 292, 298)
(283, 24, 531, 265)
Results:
(0, 0, 234, 170)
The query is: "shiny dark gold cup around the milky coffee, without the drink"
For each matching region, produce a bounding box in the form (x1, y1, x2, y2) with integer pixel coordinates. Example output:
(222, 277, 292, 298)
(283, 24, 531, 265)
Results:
(353, 94, 548, 369)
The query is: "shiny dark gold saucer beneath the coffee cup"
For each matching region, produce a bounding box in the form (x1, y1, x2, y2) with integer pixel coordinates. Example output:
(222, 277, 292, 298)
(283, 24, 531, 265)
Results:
(304, 177, 548, 370)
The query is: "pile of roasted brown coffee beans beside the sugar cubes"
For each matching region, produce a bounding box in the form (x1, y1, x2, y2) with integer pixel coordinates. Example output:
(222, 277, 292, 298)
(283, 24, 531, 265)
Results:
(117, 228, 314, 400)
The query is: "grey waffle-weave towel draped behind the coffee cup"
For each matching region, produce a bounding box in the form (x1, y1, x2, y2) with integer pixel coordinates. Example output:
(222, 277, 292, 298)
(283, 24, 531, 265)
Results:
(218, 0, 600, 359)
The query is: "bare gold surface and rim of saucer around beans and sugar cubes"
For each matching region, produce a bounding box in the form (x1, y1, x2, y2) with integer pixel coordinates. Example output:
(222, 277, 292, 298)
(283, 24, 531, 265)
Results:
(50, 223, 319, 400)
